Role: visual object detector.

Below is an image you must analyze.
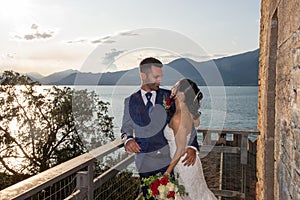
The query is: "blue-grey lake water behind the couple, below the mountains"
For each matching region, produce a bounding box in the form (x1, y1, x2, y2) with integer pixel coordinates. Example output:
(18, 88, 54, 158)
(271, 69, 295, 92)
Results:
(74, 86, 258, 138)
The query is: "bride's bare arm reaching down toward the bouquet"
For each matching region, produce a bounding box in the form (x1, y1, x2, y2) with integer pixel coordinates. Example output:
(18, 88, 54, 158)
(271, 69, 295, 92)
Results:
(165, 119, 190, 175)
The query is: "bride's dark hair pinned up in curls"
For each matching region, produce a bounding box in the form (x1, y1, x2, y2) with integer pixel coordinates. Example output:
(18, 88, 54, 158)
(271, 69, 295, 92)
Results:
(176, 78, 203, 119)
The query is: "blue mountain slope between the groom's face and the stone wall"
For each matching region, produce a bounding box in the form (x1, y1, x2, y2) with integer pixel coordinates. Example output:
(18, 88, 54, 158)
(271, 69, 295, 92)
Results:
(164, 49, 259, 86)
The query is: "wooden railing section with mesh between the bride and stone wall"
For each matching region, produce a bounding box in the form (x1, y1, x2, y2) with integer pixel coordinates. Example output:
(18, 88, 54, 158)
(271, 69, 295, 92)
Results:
(197, 129, 259, 200)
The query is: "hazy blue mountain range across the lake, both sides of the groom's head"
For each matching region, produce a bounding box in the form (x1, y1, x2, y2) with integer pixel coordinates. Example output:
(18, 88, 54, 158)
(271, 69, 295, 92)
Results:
(35, 49, 259, 86)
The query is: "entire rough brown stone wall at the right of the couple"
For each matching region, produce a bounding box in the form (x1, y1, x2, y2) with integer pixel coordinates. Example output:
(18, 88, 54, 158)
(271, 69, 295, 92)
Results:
(256, 0, 300, 200)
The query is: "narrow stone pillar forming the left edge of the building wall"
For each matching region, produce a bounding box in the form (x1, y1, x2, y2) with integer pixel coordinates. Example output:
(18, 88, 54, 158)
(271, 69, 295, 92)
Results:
(256, 1, 278, 200)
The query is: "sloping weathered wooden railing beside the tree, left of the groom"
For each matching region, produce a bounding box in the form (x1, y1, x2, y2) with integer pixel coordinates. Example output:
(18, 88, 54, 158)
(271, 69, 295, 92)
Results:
(0, 140, 134, 199)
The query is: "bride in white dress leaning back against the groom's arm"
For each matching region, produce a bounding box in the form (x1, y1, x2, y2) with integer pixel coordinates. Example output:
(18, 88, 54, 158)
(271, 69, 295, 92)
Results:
(164, 79, 216, 200)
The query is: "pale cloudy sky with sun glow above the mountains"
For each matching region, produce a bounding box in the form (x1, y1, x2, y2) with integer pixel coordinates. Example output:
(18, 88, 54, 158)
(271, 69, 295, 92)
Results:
(0, 0, 260, 76)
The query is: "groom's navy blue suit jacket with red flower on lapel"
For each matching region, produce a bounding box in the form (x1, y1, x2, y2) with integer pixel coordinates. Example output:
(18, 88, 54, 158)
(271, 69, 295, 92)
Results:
(121, 89, 199, 173)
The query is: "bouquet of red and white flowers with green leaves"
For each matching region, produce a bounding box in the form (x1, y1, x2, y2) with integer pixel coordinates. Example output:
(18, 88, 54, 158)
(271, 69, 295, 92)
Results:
(142, 173, 187, 200)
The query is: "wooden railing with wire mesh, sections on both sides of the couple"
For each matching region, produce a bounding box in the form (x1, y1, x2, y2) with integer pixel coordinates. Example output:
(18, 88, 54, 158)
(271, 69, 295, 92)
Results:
(0, 129, 259, 200)
